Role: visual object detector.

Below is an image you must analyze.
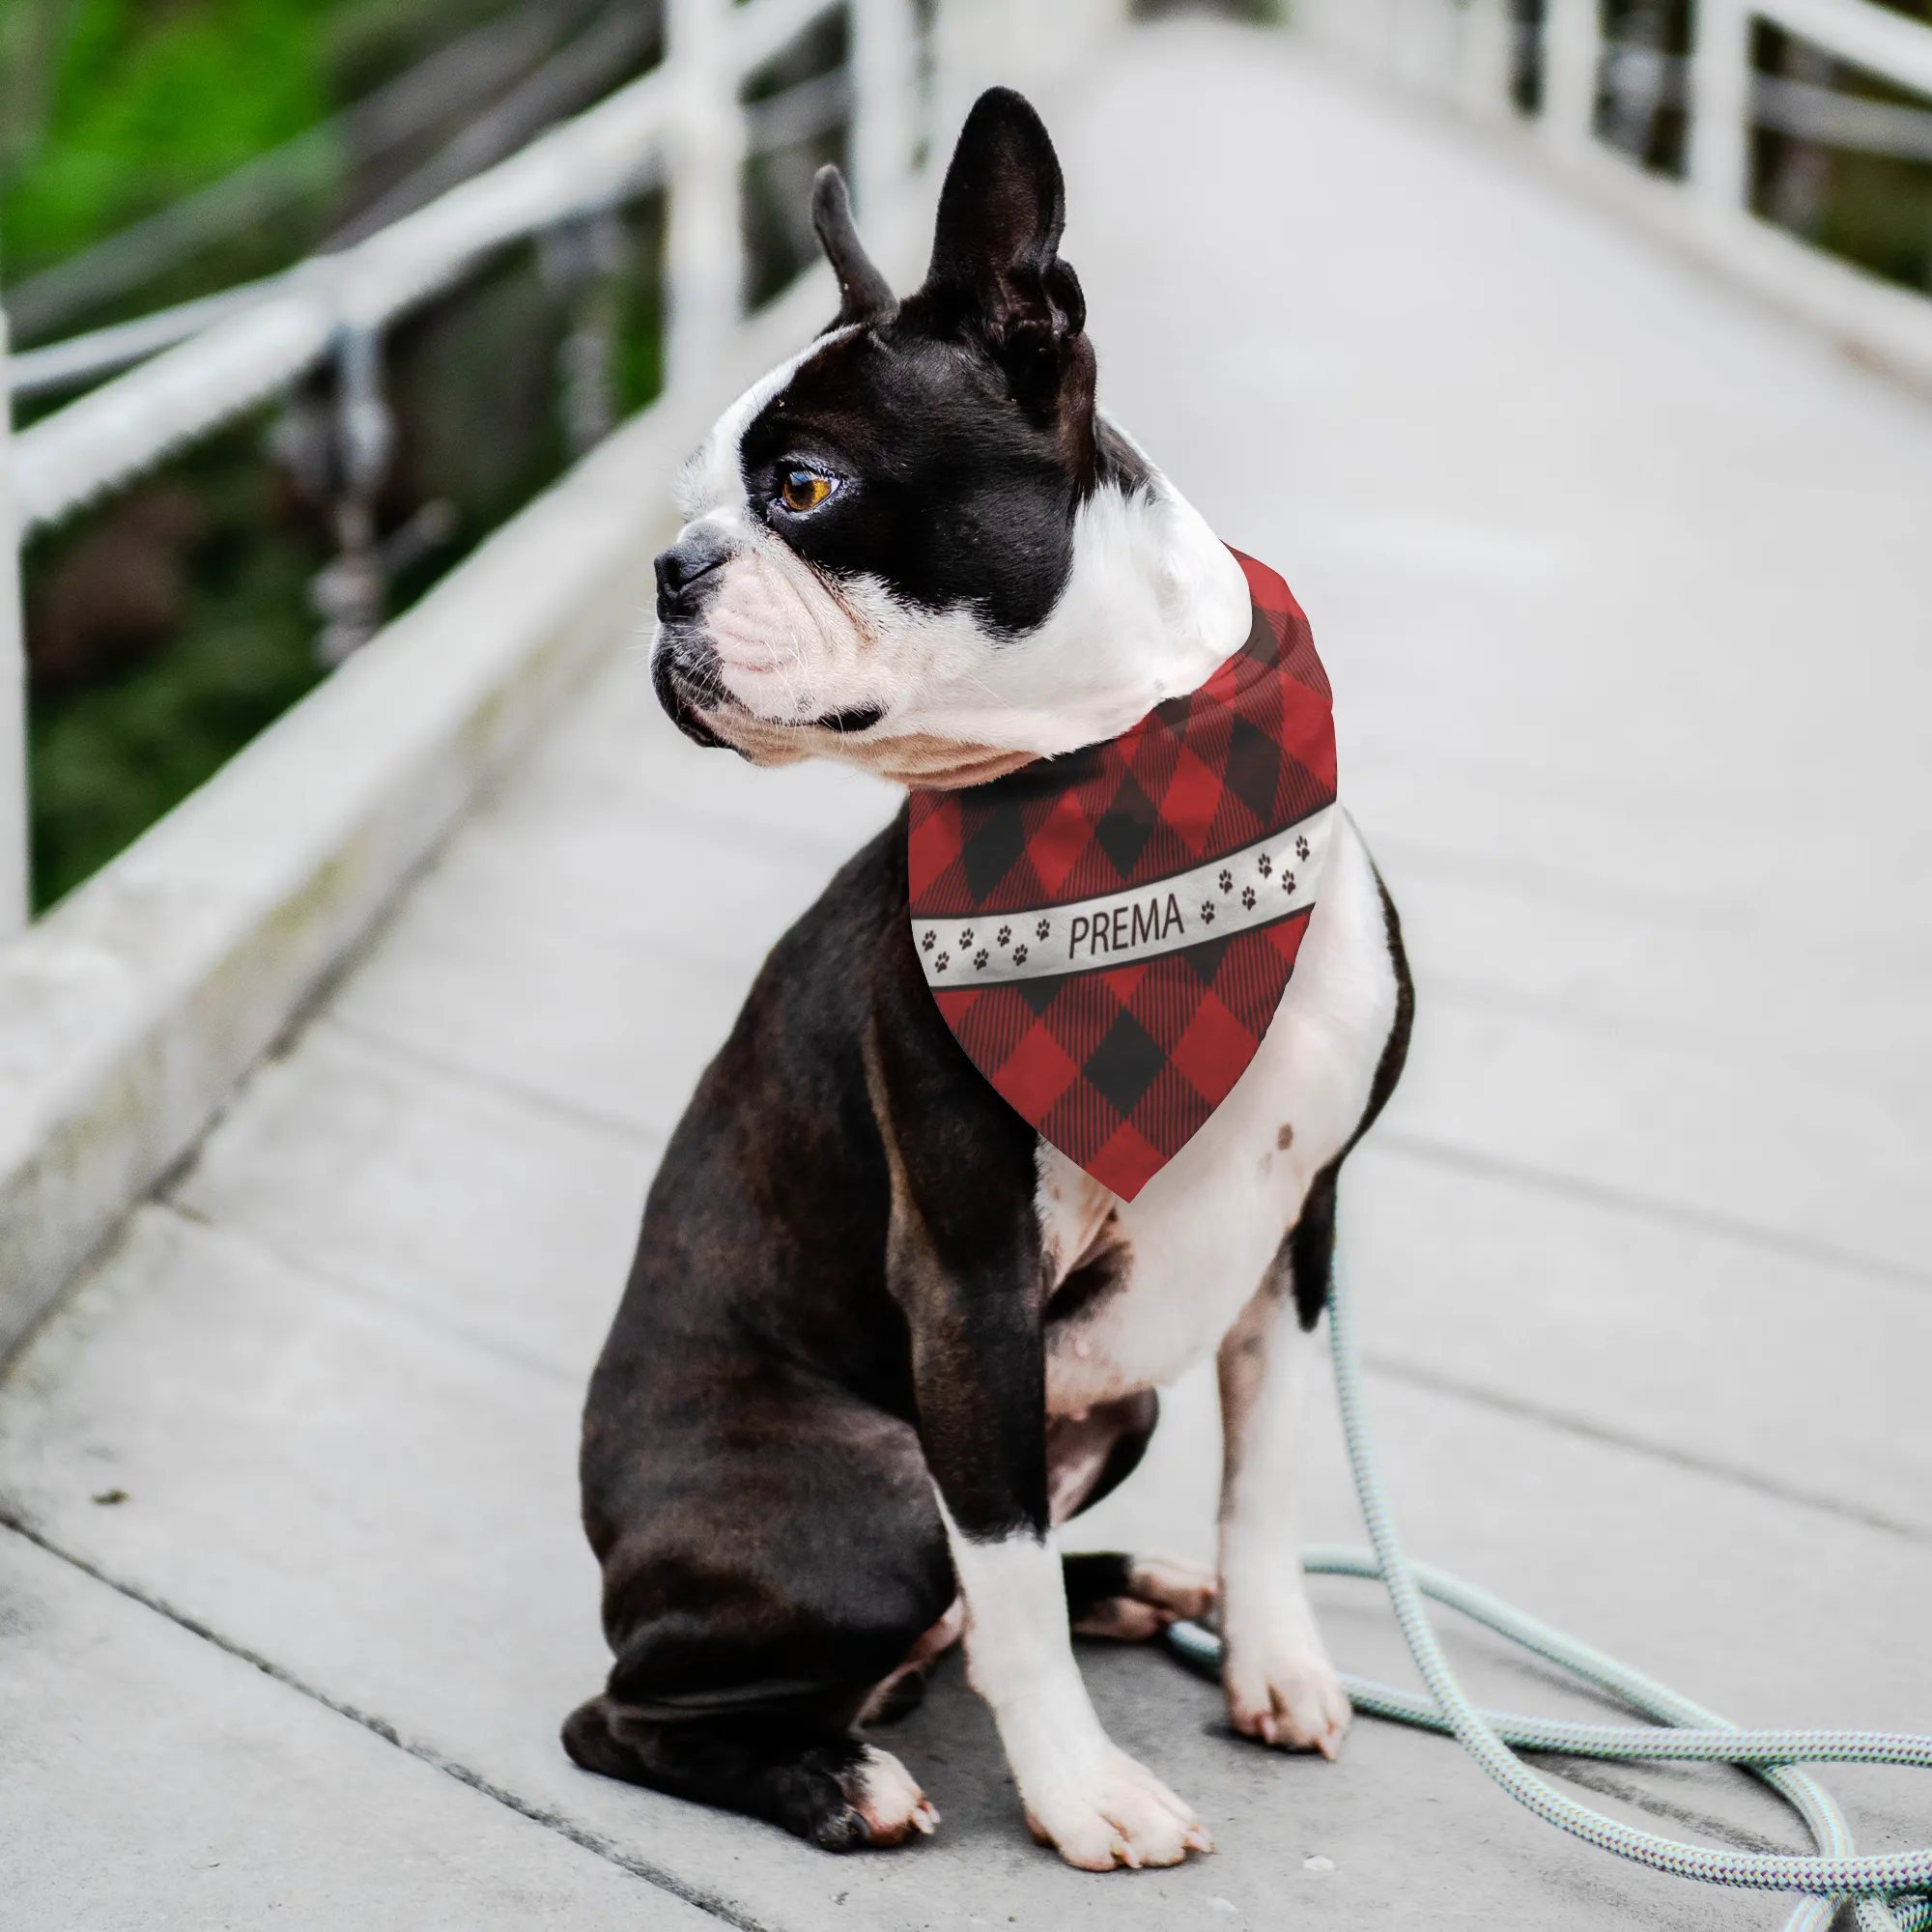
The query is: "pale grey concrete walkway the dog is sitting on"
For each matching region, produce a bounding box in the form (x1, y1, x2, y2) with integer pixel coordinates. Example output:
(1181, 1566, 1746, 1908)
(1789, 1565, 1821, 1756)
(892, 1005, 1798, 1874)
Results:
(0, 25, 1932, 1932)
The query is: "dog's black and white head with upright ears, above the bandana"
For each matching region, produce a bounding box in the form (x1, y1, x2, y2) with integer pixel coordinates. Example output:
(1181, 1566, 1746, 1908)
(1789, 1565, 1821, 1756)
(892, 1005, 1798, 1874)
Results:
(653, 89, 1248, 784)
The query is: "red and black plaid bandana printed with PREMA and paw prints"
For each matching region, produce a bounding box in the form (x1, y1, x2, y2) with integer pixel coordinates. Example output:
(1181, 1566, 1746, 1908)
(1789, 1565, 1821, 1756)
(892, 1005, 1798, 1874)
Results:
(908, 551, 1335, 1200)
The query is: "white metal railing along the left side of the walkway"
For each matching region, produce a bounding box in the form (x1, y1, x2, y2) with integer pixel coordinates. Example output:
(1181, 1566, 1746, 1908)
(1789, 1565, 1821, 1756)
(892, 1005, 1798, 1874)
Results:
(0, 0, 1124, 939)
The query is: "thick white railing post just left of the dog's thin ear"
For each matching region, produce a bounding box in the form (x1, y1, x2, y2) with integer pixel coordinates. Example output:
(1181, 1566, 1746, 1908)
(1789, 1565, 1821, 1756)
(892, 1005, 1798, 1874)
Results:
(665, 0, 744, 388)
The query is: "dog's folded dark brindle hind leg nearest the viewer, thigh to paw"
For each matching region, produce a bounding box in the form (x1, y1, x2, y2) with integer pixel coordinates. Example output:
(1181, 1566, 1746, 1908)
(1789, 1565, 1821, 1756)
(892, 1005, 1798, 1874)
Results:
(564, 1372, 954, 1851)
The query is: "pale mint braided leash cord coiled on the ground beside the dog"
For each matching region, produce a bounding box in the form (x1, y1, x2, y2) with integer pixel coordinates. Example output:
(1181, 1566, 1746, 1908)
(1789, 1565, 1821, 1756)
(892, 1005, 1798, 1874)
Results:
(1167, 1256, 1932, 1932)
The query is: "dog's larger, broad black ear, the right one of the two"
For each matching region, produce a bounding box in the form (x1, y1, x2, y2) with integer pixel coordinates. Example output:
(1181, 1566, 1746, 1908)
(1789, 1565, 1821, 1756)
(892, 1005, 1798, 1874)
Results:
(925, 87, 1086, 388)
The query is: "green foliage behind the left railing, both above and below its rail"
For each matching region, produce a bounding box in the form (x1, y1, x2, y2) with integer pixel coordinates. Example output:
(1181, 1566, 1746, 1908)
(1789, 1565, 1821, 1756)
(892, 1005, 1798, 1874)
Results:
(0, 0, 663, 908)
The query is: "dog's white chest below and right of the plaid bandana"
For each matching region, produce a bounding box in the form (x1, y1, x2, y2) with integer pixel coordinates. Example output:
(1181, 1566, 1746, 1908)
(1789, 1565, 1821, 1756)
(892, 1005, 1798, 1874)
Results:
(1036, 817, 1397, 1414)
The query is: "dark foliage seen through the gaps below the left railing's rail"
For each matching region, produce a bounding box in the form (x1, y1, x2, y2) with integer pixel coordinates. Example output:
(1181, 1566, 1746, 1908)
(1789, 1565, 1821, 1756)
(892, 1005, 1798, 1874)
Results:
(25, 208, 665, 908)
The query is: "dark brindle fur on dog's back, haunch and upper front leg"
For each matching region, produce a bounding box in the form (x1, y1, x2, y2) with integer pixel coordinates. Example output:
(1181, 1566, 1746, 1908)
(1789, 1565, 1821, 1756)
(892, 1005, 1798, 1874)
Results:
(566, 815, 1153, 1845)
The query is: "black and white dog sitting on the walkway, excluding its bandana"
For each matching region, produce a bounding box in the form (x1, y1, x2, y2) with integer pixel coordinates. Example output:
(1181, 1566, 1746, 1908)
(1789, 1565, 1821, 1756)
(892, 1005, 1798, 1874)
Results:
(564, 91, 1410, 1870)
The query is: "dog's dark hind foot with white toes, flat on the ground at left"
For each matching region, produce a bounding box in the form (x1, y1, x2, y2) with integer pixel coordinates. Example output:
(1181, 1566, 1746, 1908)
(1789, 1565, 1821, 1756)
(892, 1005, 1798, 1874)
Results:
(564, 1694, 939, 1851)
